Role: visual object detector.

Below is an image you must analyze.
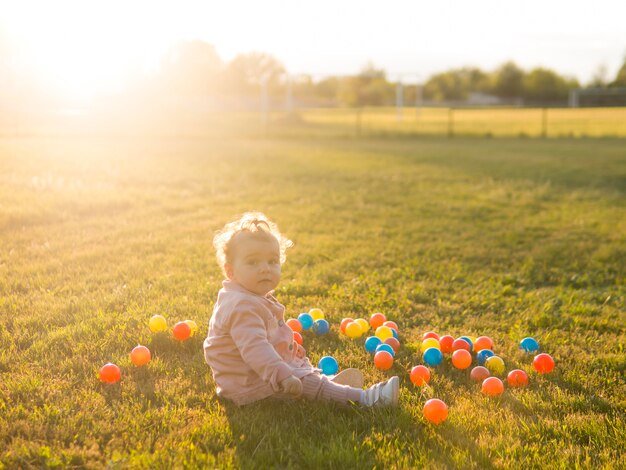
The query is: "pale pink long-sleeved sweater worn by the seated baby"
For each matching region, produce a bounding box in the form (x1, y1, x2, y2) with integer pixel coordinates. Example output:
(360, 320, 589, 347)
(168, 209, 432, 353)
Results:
(204, 281, 316, 405)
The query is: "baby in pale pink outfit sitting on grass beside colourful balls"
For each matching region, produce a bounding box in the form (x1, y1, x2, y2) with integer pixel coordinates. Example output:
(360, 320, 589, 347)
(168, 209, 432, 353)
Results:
(204, 212, 399, 407)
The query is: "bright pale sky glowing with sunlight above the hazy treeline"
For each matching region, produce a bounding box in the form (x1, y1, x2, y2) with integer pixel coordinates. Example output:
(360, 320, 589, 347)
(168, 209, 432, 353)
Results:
(0, 0, 626, 98)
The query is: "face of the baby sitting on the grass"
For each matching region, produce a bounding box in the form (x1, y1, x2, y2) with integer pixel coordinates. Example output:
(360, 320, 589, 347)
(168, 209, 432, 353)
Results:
(224, 232, 280, 296)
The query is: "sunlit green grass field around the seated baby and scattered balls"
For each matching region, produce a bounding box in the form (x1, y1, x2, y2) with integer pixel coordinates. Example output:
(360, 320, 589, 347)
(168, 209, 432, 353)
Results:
(0, 134, 626, 468)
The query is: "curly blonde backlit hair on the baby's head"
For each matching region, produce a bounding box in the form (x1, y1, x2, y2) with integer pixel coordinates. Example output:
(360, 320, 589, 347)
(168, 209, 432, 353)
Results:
(213, 212, 293, 274)
